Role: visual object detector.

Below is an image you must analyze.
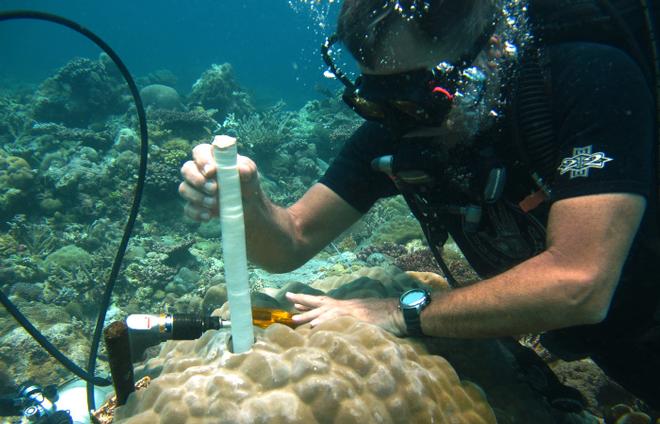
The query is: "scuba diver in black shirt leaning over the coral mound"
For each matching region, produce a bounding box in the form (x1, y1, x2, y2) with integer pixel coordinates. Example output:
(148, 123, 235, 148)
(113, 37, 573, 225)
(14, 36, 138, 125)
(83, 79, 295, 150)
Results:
(179, 0, 660, 409)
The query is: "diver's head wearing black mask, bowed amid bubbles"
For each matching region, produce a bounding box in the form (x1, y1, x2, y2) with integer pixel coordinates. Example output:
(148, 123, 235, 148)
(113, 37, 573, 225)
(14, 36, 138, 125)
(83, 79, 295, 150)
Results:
(324, 0, 498, 132)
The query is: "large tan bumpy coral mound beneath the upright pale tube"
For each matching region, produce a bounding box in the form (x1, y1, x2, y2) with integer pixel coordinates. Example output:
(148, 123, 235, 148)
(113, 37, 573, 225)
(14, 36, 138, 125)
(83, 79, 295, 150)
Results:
(114, 317, 496, 424)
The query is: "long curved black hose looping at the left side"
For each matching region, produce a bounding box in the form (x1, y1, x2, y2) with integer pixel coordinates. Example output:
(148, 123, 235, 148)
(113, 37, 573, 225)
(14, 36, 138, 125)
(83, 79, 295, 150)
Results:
(0, 10, 149, 418)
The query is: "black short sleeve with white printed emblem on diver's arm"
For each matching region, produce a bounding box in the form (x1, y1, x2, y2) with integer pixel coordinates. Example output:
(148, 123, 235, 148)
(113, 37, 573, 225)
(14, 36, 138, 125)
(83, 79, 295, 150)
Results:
(551, 43, 655, 201)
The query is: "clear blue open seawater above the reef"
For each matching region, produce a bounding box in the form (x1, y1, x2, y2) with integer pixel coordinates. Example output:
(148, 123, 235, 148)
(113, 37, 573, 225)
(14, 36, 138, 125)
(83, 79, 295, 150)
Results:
(0, 0, 338, 108)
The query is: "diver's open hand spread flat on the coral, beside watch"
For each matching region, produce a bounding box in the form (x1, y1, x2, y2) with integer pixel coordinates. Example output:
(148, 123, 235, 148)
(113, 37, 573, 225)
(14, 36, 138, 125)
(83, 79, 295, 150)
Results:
(286, 292, 406, 336)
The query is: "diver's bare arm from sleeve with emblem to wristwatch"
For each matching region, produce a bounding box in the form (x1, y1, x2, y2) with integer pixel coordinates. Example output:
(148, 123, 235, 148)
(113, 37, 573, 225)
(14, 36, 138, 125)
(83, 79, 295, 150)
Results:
(422, 193, 646, 337)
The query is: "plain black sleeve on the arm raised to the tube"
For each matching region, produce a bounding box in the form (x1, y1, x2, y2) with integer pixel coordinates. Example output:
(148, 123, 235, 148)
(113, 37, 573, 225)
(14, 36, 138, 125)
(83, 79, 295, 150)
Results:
(319, 123, 398, 213)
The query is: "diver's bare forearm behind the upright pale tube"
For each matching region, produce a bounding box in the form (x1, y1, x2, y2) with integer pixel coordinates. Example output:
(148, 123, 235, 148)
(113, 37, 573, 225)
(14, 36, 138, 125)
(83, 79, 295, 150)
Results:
(245, 183, 361, 272)
